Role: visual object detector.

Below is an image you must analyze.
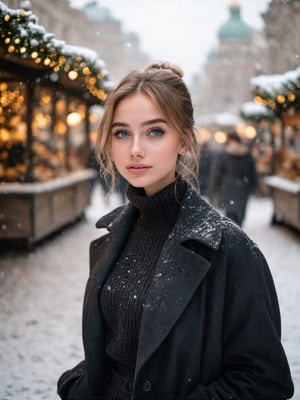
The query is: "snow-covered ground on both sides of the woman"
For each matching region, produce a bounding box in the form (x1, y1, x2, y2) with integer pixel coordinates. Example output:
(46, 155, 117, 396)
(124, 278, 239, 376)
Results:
(0, 187, 300, 400)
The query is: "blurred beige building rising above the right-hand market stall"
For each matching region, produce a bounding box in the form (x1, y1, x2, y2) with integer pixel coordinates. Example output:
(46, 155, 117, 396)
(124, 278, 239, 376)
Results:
(262, 0, 300, 74)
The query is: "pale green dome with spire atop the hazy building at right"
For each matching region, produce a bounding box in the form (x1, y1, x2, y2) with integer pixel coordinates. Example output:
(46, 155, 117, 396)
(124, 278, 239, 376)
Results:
(218, 3, 253, 39)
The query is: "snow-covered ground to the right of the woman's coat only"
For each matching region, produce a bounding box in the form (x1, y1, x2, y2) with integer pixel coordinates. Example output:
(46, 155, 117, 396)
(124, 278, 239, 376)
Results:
(245, 198, 300, 400)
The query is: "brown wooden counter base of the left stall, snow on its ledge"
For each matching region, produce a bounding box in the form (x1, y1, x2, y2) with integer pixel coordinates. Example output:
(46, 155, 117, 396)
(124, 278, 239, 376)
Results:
(0, 169, 93, 248)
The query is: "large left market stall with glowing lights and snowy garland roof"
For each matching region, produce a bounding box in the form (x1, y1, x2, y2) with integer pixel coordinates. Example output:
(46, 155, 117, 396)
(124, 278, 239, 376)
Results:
(0, 3, 110, 247)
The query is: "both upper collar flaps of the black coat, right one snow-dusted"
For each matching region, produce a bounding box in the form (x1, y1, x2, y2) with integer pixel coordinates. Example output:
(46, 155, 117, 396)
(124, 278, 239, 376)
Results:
(96, 186, 222, 250)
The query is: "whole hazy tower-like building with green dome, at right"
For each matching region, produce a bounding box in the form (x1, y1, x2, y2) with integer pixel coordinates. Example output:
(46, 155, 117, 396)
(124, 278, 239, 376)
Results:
(199, 1, 260, 120)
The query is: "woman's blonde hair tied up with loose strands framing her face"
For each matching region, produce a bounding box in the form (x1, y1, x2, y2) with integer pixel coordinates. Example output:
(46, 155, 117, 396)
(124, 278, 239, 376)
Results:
(96, 62, 198, 189)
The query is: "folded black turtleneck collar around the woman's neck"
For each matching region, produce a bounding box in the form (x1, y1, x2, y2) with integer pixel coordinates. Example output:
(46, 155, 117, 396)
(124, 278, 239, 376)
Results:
(127, 179, 187, 229)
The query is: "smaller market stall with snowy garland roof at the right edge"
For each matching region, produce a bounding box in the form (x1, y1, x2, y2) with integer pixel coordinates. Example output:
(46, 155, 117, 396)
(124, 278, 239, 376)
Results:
(250, 68, 300, 230)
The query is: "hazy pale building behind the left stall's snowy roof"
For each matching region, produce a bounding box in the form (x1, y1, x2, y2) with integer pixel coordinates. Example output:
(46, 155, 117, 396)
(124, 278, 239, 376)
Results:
(6, 0, 149, 81)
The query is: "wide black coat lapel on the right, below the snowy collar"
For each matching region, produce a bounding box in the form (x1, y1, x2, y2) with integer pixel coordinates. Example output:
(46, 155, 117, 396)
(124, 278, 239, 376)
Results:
(137, 238, 210, 370)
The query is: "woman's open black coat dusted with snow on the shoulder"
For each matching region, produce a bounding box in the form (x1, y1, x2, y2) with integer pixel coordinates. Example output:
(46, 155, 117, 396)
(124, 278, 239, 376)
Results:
(58, 188, 293, 400)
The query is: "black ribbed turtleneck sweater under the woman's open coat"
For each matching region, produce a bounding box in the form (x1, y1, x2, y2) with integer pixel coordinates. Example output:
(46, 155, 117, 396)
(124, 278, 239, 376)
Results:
(100, 180, 186, 369)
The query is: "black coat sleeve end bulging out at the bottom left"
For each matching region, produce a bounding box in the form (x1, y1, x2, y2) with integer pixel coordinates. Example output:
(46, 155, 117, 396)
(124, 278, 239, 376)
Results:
(57, 361, 89, 400)
